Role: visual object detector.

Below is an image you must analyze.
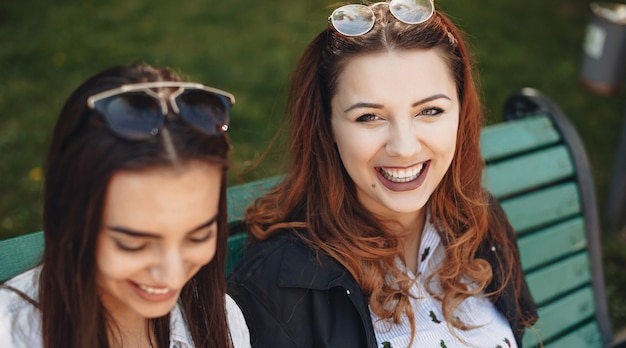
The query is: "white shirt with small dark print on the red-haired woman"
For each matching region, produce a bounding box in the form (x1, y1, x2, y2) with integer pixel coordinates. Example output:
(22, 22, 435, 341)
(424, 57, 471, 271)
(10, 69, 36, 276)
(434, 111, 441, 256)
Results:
(370, 216, 517, 348)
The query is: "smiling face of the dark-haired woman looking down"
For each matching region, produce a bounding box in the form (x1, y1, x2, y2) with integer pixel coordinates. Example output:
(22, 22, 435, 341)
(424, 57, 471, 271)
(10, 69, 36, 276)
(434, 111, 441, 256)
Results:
(96, 162, 222, 323)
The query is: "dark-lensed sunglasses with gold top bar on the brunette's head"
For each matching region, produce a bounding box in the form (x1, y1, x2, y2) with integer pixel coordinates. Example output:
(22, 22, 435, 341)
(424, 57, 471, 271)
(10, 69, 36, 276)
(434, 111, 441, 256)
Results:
(87, 81, 235, 140)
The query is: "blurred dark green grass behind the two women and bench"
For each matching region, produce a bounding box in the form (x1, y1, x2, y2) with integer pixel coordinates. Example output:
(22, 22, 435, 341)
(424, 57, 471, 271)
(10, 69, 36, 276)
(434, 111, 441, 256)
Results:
(0, 0, 626, 327)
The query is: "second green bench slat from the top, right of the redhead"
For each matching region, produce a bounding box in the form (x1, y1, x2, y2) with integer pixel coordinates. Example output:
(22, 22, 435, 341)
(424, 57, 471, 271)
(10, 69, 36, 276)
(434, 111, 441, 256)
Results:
(483, 145, 574, 198)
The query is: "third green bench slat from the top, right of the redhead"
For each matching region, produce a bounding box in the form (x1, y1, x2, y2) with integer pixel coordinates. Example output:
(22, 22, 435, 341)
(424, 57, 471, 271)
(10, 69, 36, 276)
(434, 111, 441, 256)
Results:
(502, 182, 581, 233)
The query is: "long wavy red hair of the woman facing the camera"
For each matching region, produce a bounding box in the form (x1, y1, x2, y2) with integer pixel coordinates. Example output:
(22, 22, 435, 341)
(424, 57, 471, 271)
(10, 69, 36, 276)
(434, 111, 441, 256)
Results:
(246, 6, 521, 342)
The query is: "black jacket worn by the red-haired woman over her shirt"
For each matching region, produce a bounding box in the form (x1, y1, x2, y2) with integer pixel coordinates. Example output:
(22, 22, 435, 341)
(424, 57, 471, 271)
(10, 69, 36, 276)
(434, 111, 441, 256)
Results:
(228, 209, 536, 348)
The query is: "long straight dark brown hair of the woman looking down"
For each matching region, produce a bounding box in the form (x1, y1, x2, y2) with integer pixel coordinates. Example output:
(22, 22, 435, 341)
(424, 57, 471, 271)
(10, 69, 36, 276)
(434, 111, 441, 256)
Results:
(35, 64, 232, 348)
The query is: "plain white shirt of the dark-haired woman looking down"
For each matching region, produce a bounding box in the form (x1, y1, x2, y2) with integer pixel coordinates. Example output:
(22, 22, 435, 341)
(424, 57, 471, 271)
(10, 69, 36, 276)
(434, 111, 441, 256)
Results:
(0, 267, 250, 348)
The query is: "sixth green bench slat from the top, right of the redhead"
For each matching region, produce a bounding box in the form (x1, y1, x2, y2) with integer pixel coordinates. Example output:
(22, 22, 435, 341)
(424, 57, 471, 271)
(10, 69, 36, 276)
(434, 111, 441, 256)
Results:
(522, 287, 595, 347)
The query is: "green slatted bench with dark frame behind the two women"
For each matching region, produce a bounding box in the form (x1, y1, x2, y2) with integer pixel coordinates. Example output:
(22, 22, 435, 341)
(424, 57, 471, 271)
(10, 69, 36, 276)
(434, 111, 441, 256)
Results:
(0, 89, 623, 348)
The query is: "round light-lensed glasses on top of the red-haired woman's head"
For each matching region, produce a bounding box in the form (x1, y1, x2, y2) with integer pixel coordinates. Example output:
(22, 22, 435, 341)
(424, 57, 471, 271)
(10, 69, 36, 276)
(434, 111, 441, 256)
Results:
(328, 0, 435, 36)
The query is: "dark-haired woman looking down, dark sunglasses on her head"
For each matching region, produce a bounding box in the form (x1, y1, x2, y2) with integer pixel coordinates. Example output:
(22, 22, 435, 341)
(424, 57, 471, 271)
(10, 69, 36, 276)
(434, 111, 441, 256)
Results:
(0, 64, 250, 348)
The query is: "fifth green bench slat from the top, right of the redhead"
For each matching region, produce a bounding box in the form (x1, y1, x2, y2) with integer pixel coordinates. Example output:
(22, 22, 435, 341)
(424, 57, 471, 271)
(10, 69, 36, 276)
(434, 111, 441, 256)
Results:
(526, 253, 591, 305)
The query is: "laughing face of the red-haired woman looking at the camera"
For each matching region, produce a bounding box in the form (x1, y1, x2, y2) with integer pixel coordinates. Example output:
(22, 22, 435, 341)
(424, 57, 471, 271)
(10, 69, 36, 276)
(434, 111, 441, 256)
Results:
(331, 49, 459, 227)
